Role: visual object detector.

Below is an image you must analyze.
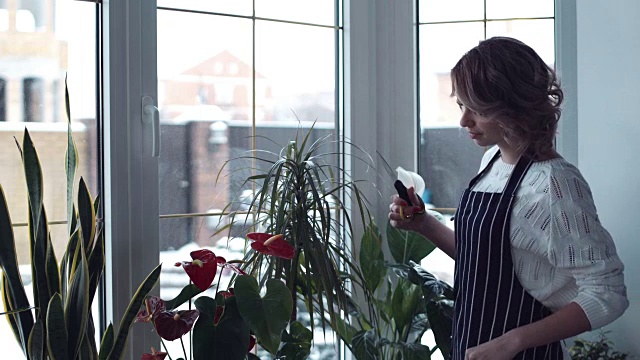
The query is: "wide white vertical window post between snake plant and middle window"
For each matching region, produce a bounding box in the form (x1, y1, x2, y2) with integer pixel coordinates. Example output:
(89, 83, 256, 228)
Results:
(102, 0, 159, 359)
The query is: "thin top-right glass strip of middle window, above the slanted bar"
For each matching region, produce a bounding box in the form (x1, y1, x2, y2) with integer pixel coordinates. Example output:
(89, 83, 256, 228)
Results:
(255, 0, 336, 25)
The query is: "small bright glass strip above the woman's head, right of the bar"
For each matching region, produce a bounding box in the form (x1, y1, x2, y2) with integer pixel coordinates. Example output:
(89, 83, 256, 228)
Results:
(488, 0, 554, 19)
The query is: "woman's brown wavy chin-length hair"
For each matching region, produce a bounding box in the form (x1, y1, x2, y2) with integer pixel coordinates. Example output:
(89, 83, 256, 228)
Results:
(451, 37, 564, 157)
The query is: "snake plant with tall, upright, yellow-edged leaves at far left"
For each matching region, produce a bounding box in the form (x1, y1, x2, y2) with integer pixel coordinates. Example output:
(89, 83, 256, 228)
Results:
(0, 83, 160, 360)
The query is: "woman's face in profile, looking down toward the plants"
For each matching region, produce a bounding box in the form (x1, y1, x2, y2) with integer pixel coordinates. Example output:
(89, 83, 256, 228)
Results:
(457, 100, 506, 148)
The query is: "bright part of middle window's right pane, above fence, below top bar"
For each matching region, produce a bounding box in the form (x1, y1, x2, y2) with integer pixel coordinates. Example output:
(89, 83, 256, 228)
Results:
(256, 21, 336, 128)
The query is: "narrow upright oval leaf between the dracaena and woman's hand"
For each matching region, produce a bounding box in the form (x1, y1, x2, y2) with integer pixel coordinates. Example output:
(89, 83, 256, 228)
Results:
(359, 222, 387, 293)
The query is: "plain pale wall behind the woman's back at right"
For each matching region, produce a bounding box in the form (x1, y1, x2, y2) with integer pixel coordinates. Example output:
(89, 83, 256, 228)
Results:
(559, 0, 640, 355)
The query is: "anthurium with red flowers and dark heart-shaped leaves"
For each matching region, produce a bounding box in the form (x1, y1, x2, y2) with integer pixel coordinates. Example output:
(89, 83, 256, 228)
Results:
(136, 243, 312, 360)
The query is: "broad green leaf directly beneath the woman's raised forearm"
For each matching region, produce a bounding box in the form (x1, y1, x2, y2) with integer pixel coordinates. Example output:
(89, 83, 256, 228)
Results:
(387, 222, 435, 264)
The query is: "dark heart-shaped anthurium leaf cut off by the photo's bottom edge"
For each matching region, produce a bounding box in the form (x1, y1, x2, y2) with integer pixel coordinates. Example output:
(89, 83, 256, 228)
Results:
(193, 296, 249, 360)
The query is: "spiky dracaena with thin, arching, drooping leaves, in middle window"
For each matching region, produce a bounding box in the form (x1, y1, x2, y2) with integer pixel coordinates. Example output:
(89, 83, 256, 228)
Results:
(215, 127, 373, 334)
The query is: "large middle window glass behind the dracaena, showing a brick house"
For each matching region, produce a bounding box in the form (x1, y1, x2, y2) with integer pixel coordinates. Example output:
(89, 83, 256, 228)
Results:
(157, 0, 342, 358)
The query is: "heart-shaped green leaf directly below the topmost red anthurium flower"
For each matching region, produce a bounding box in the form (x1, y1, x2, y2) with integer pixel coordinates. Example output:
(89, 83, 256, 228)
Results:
(234, 275, 293, 354)
